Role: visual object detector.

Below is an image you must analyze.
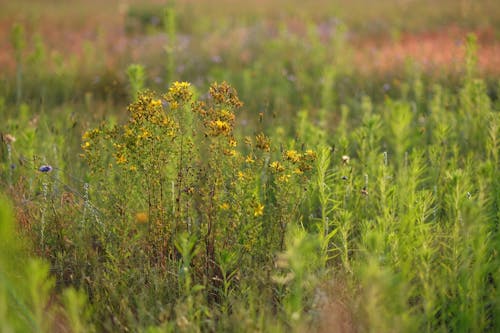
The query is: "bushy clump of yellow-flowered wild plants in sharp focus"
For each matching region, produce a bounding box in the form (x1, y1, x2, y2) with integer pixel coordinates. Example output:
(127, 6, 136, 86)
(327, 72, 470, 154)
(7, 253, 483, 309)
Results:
(75, 82, 316, 328)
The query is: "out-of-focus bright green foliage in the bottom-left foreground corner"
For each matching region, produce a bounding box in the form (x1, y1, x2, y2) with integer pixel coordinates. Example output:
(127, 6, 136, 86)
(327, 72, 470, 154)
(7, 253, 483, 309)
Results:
(0, 197, 92, 332)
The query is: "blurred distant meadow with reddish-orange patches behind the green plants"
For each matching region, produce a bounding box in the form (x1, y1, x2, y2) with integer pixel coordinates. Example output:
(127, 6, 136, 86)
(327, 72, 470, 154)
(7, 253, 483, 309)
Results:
(0, 0, 500, 109)
